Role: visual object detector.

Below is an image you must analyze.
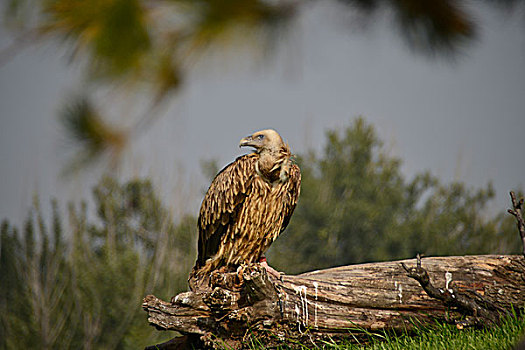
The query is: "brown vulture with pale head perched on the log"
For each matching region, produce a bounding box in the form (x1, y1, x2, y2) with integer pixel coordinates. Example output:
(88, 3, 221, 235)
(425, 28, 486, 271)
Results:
(190, 129, 301, 279)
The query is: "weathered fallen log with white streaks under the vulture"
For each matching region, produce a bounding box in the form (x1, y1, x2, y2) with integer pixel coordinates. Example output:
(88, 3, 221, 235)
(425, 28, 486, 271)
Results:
(143, 255, 525, 348)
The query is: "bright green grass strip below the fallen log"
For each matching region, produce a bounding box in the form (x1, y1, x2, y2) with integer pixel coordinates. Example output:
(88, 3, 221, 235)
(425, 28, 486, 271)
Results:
(246, 314, 525, 350)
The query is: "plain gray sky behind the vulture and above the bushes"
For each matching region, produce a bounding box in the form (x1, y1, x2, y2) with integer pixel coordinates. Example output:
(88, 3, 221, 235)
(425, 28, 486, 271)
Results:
(0, 5, 525, 227)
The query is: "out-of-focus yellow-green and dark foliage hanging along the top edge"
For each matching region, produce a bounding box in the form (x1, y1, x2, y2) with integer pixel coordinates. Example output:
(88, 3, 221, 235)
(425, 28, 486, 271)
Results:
(0, 0, 523, 169)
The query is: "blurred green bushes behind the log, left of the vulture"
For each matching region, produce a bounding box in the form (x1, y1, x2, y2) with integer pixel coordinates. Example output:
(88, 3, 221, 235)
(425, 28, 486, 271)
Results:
(0, 178, 197, 349)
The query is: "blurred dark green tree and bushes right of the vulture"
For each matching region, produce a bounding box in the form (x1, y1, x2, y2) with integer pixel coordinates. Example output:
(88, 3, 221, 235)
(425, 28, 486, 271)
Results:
(268, 118, 520, 273)
